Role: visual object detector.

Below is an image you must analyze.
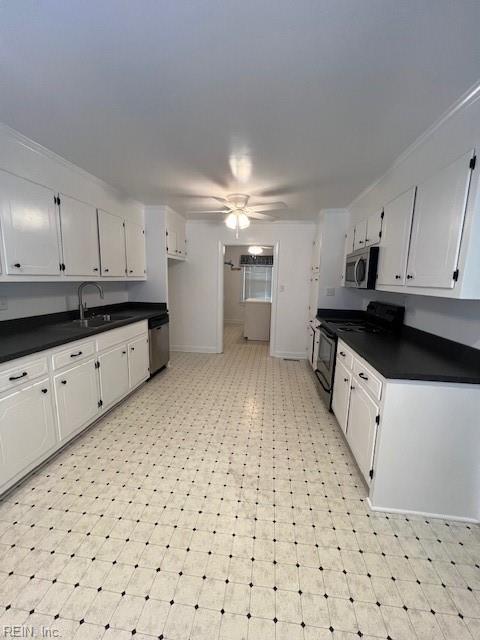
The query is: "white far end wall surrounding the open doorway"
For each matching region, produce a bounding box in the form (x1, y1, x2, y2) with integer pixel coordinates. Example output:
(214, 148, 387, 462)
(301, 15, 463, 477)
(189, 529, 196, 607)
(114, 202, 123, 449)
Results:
(168, 221, 315, 357)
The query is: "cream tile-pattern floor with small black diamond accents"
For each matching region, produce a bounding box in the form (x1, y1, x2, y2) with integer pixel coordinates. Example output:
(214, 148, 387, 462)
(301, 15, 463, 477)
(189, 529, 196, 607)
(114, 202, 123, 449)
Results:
(0, 327, 480, 640)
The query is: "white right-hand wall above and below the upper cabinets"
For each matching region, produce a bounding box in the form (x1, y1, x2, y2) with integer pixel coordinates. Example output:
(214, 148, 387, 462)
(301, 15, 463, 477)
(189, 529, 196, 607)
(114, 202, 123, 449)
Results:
(349, 87, 480, 348)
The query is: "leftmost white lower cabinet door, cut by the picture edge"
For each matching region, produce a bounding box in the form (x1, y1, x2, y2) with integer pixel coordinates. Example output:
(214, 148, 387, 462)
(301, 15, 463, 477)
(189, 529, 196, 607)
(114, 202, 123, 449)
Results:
(0, 378, 56, 487)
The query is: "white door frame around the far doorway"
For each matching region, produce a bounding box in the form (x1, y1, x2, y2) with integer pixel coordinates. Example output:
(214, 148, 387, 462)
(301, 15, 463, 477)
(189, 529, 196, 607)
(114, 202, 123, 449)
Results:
(215, 240, 280, 357)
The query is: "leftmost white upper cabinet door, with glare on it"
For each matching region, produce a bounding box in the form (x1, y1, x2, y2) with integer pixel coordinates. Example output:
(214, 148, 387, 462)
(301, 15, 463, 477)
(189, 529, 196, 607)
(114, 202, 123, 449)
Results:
(0, 171, 60, 276)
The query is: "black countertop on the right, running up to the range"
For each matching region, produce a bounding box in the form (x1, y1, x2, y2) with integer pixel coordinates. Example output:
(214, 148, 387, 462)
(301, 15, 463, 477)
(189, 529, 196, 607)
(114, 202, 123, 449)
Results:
(317, 309, 480, 384)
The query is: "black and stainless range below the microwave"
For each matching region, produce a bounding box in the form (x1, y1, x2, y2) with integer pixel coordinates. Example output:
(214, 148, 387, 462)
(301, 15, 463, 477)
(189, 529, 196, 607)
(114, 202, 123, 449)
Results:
(314, 301, 405, 409)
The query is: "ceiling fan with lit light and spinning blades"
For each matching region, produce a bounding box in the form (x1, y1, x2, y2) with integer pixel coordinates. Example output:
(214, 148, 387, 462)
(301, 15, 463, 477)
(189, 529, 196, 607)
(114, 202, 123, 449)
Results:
(190, 193, 287, 238)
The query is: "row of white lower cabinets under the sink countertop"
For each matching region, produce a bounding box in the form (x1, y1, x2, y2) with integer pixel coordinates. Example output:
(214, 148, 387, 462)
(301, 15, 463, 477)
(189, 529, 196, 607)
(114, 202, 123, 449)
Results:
(0, 320, 149, 495)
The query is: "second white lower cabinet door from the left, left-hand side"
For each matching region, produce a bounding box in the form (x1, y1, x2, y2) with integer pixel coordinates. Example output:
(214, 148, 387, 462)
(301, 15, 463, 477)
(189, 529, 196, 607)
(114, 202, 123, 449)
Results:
(54, 359, 99, 441)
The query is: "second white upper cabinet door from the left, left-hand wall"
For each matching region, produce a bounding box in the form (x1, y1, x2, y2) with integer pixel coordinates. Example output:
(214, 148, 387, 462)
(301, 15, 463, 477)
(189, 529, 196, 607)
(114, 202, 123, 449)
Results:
(60, 195, 100, 277)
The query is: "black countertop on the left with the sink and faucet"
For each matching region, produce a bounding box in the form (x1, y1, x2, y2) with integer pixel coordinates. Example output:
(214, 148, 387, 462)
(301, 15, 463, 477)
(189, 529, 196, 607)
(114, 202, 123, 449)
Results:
(0, 302, 167, 363)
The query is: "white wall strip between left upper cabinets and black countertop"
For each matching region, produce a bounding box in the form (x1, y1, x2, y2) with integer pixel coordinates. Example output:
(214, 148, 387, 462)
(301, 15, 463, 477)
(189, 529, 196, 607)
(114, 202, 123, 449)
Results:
(0, 282, 128, 320)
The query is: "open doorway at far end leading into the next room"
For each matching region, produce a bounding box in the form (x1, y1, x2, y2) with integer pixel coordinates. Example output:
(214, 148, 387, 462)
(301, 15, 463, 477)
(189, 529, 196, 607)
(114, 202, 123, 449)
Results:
(217, 243, 278, 355)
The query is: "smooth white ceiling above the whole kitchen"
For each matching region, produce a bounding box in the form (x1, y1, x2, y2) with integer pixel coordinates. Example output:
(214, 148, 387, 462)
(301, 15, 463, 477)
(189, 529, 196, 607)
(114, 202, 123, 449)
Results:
(0, 0, 480, 218)
